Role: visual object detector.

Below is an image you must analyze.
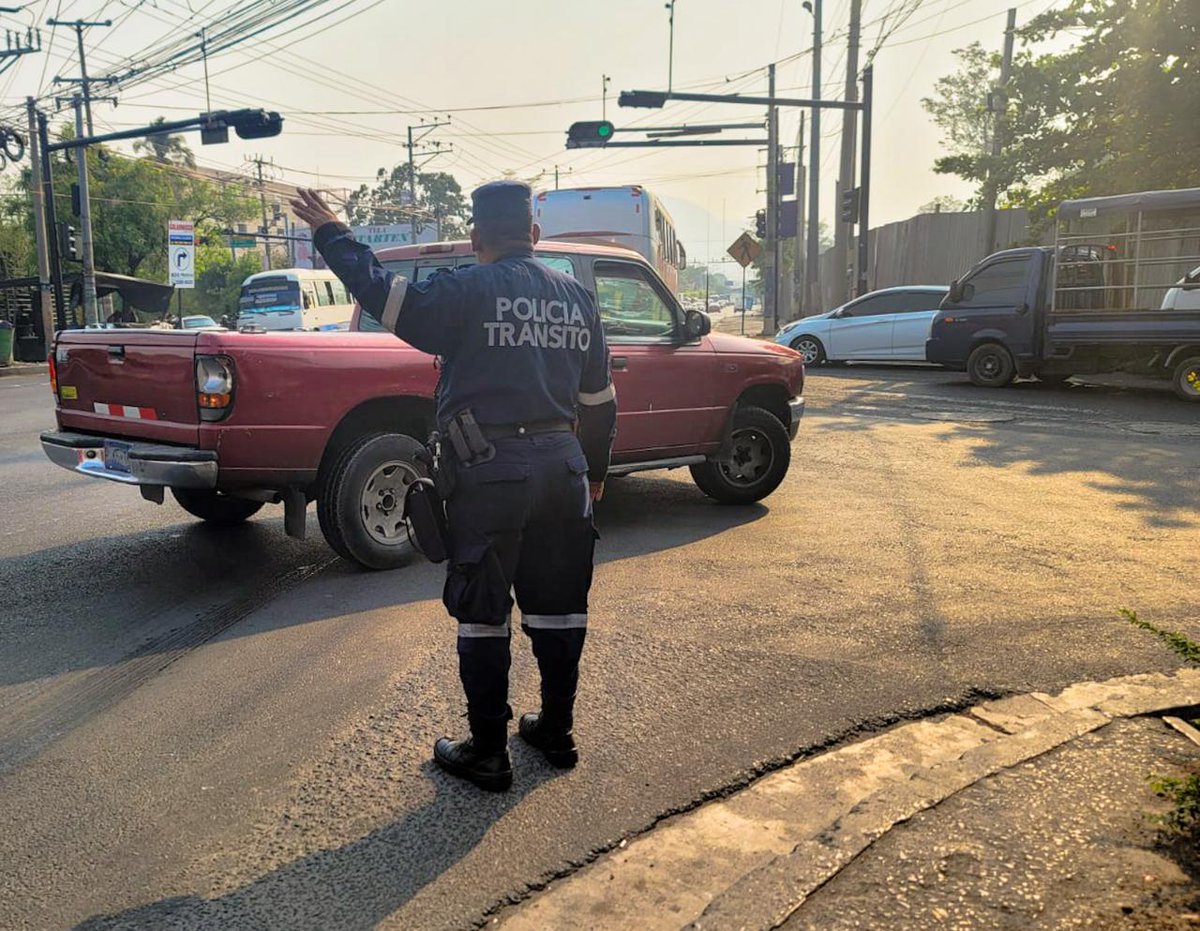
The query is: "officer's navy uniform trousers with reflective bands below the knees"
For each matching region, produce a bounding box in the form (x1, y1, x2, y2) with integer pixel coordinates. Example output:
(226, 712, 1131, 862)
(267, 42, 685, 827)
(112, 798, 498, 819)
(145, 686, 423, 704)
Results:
(443, 431, 596, 745)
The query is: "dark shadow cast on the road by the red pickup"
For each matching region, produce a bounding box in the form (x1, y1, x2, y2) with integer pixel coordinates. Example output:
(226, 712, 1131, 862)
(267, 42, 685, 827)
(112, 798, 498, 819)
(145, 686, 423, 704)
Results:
(0, 476, 768, 686)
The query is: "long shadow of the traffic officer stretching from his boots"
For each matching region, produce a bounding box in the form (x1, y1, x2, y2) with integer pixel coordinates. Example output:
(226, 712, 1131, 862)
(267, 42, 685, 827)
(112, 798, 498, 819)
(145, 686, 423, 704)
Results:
(76, 763, 558, 931)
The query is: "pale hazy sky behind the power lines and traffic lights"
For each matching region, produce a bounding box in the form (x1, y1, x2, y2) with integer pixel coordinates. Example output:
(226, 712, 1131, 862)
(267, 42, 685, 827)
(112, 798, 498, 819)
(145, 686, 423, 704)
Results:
(0, 0, 1054, 259)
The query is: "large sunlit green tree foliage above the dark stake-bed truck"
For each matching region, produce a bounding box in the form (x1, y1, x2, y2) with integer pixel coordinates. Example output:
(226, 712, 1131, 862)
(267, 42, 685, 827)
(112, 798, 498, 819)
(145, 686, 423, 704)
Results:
(926, 0, 1200, 220)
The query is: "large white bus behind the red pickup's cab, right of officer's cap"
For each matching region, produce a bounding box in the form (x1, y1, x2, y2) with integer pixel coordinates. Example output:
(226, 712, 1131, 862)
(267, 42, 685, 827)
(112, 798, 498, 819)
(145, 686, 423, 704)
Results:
(533, 185, 688, 293)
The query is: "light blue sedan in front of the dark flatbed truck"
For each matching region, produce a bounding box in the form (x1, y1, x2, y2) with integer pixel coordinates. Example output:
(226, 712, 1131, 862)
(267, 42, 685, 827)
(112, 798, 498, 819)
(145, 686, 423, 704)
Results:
(775, 284, 949, 366)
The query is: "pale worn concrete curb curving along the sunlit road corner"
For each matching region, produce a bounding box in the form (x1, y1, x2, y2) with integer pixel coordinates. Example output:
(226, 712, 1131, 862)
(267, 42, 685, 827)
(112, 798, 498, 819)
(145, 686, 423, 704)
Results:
(490, 668, 1200, 931)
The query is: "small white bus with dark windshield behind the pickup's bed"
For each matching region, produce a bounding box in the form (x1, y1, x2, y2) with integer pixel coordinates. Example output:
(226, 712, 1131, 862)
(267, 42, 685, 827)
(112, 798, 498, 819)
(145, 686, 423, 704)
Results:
(238, 269, 354, 330)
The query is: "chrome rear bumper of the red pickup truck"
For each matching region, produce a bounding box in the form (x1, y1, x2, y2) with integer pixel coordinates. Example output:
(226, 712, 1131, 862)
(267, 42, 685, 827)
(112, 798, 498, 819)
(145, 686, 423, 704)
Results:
(42, 431, 217, 488)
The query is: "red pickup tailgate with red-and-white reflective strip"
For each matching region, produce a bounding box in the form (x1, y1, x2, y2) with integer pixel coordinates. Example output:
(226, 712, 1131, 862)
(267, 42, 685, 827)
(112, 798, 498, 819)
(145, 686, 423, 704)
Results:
(54, 330, 199, 445)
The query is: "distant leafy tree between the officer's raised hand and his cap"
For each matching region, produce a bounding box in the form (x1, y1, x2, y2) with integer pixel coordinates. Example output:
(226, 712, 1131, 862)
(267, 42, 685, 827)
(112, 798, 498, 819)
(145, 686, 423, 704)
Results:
(346, 162, 470, 239)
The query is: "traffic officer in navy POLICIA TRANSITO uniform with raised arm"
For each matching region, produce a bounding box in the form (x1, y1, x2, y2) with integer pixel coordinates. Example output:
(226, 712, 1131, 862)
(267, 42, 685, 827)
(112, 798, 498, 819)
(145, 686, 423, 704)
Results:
(292, 181, 617, 791)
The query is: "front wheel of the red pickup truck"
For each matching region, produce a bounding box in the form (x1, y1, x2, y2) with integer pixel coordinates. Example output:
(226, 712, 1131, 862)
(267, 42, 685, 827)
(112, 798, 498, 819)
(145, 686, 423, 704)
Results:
(691, 407, 792, 504)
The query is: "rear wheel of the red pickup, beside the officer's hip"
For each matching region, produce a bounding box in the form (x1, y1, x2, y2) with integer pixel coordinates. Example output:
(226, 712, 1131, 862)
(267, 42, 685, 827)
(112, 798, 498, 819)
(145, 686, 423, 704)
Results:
(317, 433, 425, 569)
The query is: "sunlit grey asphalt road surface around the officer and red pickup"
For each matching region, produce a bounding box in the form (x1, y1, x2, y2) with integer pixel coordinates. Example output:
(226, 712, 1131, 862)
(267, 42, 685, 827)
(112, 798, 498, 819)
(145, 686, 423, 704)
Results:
(0, 366, 1200, 929)
